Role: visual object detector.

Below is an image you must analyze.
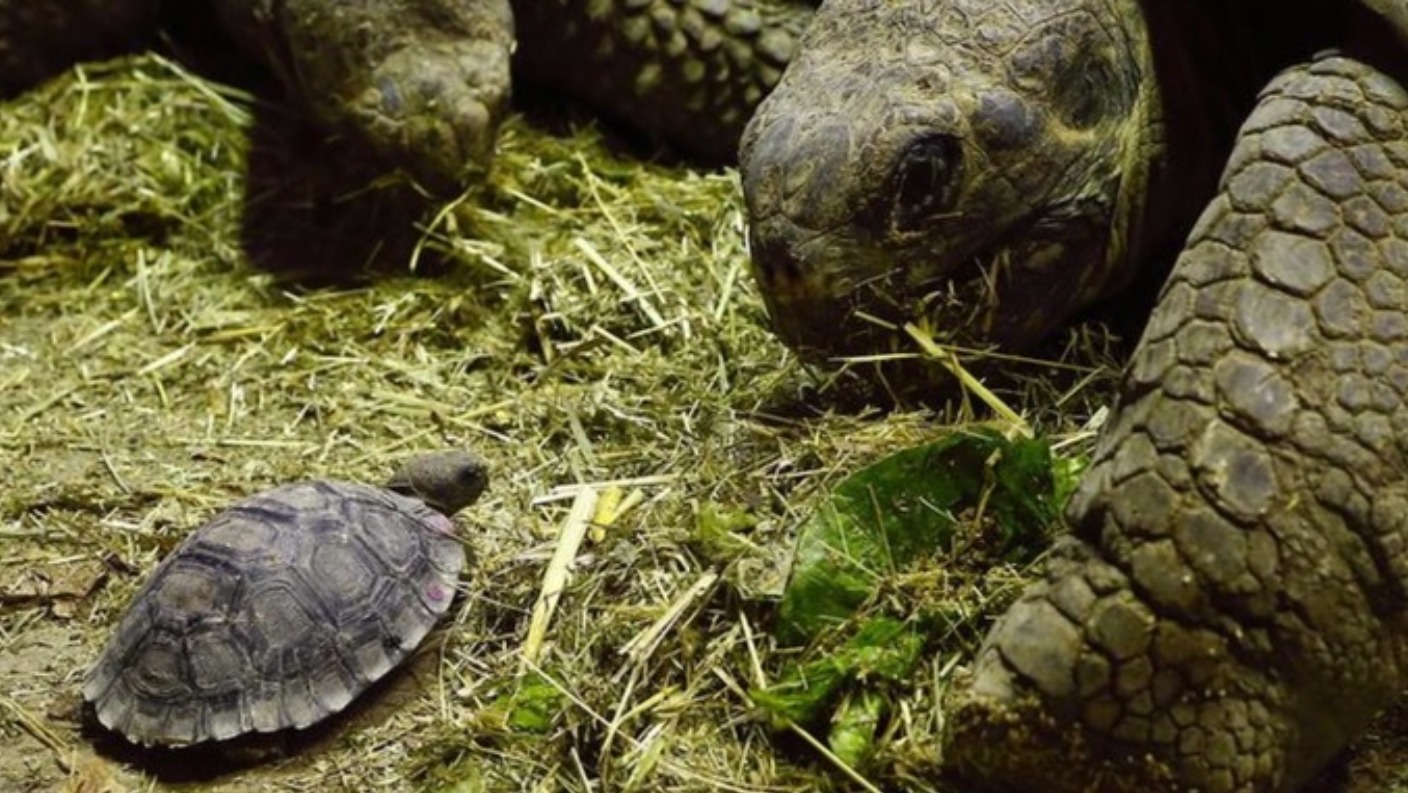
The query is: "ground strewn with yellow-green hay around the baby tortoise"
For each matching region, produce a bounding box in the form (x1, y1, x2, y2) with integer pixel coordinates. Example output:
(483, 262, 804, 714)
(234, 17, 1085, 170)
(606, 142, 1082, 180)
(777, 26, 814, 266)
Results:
(0, 52, 1408, 793)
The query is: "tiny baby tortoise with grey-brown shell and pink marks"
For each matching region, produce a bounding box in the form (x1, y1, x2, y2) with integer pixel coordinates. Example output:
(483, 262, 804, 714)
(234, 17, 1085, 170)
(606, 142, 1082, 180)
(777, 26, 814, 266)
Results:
(83, 452, 486, 747)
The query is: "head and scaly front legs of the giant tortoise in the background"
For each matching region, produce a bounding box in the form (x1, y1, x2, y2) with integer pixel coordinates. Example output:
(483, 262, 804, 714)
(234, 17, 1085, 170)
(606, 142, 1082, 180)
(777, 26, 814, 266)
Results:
(0, 0, 811, 192)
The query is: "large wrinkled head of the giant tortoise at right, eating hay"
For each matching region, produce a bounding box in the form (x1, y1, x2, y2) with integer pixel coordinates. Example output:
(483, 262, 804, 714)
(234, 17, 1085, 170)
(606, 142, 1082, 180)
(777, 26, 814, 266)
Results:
(741, 0, 1159, 358)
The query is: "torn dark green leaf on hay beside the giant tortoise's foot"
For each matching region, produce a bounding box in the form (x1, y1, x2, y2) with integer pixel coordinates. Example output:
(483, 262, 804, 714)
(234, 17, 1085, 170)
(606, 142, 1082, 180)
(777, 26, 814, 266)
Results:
(750, 430, 1079, 766)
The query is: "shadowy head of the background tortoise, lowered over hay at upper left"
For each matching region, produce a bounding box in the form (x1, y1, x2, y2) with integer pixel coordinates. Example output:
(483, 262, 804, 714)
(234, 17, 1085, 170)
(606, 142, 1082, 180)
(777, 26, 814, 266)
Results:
(215, 0, 513, 192)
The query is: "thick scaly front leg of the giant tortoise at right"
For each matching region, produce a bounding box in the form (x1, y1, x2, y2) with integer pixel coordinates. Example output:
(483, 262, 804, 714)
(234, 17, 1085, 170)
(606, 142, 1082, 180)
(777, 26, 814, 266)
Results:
(945, 52, 1408, 793)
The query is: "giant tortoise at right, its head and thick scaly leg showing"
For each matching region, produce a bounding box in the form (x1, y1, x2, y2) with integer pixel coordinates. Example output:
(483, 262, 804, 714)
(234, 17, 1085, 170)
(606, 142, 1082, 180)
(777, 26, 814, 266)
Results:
(741, 0, 1408, 793)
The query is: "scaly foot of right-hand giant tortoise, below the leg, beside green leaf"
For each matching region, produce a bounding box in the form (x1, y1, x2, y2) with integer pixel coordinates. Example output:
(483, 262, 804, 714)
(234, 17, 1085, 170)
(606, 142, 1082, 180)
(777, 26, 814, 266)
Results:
(945, 539, 1295, 793)
